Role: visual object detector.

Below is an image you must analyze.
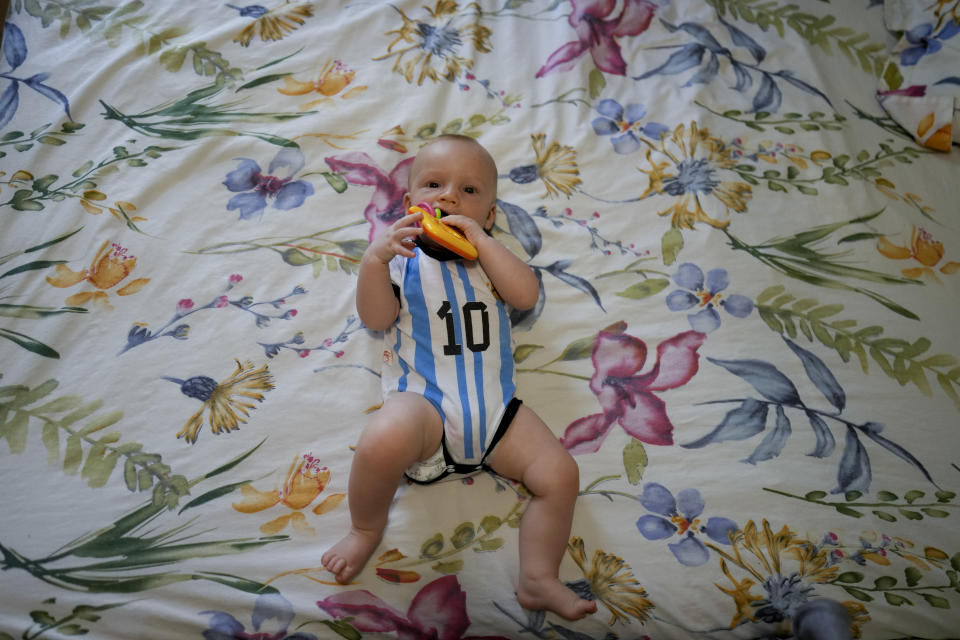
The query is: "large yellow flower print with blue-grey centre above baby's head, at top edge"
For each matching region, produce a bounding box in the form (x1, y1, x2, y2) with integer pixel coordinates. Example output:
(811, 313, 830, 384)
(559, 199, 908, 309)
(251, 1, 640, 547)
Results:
(374, 0, 492, 85)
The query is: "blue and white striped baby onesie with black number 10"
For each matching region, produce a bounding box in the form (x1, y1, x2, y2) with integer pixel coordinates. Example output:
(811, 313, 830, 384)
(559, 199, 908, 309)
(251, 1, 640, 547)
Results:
(381, 245, 519, 482)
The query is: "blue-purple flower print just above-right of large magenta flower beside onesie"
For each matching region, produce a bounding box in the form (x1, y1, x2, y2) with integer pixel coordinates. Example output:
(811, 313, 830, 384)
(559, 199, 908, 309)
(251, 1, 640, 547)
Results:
(667, 262, 753, 333)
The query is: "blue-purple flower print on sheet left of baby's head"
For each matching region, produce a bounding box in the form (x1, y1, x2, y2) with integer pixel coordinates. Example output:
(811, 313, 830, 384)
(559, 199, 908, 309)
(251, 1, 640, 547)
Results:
(223, 147, 313, 220)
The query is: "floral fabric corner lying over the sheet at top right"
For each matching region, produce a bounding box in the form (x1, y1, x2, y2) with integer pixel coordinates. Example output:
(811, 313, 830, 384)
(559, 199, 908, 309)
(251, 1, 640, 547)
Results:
(877, 0, 960, 151)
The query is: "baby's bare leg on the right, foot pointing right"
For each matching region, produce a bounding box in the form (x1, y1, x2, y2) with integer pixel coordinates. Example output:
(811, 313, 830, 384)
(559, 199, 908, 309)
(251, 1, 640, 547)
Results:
(490, 405, 597, 620)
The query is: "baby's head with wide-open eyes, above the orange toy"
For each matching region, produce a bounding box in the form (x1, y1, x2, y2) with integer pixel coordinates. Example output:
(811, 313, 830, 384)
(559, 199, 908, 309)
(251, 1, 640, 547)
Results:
(404, 139, 497, 229)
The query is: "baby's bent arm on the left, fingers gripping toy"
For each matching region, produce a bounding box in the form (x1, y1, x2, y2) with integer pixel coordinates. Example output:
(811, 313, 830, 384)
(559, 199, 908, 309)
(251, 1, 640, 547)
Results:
(357, 213, 421, 331)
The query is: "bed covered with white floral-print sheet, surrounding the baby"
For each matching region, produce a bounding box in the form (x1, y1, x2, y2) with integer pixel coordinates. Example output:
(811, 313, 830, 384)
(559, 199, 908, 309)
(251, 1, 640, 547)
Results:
(0, 0, 960, 640)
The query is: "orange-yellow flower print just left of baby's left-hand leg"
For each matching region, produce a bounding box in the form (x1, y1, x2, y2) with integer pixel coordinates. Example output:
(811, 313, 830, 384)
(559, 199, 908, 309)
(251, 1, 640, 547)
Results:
(233, 453, 346, 535)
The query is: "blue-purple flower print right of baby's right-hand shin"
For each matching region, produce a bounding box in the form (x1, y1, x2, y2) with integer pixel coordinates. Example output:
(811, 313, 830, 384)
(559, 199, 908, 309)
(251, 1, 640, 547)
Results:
(637, 482, 739, 567)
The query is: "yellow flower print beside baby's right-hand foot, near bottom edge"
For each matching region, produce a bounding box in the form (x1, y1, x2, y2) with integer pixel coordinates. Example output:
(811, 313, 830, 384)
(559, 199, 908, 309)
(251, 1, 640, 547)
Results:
(567, 537, 654, 624)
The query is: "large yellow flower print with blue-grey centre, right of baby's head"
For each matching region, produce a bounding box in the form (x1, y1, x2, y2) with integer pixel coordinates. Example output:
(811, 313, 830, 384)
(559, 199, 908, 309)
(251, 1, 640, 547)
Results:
(638, 122, 753, 229)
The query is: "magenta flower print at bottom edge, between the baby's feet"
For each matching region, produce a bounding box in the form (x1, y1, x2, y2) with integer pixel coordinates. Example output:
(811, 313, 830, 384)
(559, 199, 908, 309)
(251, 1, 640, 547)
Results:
(317, 575, 508, 640)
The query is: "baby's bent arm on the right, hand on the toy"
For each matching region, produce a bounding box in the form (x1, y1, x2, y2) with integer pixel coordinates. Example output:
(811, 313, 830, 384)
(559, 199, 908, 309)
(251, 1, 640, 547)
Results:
(443, 215, 540, 311)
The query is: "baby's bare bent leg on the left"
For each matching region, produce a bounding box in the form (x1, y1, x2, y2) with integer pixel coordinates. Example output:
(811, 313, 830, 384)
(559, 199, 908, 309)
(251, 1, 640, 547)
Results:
(321, 393, 443, 584)
